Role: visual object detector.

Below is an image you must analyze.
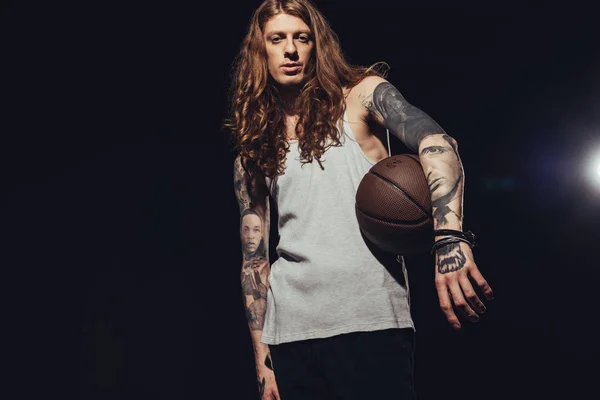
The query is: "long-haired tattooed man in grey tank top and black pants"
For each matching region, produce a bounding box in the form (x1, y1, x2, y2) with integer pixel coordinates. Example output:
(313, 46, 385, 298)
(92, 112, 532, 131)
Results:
(224, 0, 492, 400)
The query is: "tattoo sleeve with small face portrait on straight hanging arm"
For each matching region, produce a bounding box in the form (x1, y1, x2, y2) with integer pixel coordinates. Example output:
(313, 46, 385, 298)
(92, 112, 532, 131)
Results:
(234, 156, 270, 330)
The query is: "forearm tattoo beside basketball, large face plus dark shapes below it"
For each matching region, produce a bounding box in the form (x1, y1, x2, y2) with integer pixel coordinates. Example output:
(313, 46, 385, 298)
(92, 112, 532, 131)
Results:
(420, 134, 463, 226)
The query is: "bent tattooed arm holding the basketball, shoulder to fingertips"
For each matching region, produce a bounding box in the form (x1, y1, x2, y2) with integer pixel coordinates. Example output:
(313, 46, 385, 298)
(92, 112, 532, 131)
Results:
(358, 77, 493, 329)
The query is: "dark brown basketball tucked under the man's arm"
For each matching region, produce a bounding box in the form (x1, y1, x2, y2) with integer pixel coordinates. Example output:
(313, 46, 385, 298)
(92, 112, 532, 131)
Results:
(355, 154, 434, 256)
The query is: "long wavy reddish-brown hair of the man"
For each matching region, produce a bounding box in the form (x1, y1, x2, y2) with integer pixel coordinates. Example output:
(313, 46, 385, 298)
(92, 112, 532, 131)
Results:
(223, 0, 387, 177)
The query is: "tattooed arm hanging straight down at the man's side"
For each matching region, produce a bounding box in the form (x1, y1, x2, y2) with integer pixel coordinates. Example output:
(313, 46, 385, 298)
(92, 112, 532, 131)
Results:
(233, 157, 279, 399)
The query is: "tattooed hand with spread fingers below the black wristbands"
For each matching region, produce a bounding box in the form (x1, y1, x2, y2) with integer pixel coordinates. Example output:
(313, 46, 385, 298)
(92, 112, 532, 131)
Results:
(435, 242, 494, 329)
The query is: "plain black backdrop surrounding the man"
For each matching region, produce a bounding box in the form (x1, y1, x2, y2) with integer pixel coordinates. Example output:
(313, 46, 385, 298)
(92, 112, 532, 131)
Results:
(0, 0, 600, 400)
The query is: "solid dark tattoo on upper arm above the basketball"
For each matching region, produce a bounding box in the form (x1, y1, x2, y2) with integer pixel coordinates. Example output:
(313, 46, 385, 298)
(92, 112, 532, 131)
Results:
(361, 82, 445, 153)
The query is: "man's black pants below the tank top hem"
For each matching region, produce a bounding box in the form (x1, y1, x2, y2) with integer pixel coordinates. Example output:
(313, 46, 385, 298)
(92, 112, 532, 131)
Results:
(269, 328, 416, 400)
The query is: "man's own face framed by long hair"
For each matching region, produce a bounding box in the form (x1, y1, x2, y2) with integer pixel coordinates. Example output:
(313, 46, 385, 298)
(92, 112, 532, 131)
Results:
(264, 14, 314, 86)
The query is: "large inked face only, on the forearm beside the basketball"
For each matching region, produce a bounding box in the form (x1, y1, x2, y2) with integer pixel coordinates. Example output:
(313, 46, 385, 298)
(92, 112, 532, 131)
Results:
(421, 136, 461, 200)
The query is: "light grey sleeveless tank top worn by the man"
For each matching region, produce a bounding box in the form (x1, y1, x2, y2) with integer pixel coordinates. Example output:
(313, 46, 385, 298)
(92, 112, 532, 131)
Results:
(261, 114, 414, 344)
